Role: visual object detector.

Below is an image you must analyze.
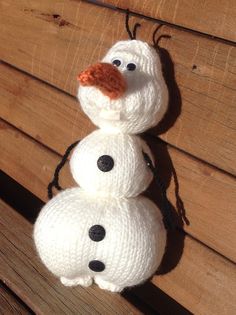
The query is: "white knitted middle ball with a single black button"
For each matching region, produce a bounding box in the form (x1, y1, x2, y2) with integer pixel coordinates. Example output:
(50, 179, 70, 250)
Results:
(70, 129, 153, 197)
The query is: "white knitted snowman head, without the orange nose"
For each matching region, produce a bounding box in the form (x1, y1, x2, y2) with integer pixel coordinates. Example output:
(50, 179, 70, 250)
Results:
(78, 40, 168, 134)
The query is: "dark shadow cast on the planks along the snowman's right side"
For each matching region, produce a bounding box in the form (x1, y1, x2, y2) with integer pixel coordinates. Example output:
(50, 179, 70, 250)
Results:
(143, 43, 190, 274)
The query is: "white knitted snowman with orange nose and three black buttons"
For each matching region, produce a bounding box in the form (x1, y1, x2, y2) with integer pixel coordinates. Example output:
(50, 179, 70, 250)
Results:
(34, 40, 168, 292)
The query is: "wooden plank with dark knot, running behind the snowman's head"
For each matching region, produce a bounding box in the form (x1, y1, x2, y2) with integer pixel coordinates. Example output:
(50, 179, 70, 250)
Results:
(0, 0, 236, 174)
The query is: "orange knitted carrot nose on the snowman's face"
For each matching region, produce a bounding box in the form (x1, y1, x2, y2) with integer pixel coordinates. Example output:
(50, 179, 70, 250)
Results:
(78, 63, 126, 100)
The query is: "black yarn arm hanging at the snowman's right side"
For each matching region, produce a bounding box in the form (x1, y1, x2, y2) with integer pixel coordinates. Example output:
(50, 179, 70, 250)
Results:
(143, 152, 175, 229)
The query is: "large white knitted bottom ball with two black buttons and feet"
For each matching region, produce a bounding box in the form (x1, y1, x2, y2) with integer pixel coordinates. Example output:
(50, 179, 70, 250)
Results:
(34, 188, 166, 292)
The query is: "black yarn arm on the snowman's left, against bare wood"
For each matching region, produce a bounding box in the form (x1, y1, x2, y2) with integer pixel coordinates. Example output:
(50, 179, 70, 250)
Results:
(48, 141, 79, 199)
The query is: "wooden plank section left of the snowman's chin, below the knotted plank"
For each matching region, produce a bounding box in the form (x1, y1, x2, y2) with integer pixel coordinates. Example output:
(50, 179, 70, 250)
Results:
(0, 63, 95, 153)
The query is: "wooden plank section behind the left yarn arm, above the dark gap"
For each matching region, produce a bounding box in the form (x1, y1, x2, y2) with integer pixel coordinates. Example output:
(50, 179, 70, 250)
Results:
(0, 121, 75, 202)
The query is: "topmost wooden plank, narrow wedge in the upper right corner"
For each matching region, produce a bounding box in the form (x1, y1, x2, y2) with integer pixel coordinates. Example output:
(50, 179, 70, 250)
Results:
(100, 0, 236, 41)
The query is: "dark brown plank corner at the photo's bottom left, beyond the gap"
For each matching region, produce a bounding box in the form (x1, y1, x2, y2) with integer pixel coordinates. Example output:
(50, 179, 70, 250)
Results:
(0, 282, 33, 315)
